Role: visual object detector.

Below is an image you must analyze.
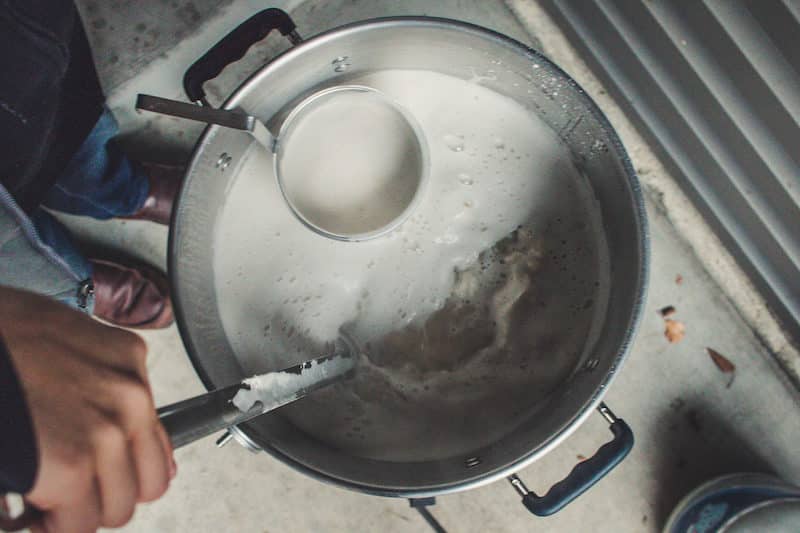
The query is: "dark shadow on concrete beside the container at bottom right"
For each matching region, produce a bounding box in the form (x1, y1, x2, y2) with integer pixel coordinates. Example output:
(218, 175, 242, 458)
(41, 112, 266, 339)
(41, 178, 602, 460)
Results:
(651, 397, 775, 527)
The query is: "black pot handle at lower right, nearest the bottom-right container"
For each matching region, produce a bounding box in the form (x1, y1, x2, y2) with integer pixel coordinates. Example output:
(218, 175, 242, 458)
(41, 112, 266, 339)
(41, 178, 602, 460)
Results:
(508, 403, 633, 516)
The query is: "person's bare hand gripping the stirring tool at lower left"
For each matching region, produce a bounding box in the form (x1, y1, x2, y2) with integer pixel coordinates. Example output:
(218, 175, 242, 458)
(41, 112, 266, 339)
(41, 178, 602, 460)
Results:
(0, 288, 176, 533)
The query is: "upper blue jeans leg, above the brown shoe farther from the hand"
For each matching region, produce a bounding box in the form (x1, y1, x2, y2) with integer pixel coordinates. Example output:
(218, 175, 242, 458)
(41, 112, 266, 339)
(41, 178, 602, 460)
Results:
(43, 109, 150, 220)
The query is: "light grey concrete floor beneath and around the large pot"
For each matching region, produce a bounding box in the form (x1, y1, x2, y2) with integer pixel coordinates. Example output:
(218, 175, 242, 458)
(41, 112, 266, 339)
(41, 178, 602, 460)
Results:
(57, 0, 800, 533)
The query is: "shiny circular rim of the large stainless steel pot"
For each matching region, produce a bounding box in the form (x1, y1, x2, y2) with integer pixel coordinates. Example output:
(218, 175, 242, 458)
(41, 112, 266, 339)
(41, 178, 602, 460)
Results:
(169, 11, 650, 512)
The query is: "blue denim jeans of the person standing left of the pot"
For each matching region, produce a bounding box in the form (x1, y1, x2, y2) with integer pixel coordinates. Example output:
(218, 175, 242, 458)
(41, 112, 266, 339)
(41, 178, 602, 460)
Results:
(31, 109, 150, 279)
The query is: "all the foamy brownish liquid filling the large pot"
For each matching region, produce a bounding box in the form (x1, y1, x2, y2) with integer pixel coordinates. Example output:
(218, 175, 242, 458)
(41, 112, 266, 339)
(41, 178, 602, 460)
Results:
(214, 70, 608, 460)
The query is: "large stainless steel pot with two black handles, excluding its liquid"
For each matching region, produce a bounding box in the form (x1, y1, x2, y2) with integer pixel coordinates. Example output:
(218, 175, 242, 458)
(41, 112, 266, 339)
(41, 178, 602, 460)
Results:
(169, 10, 648, 515)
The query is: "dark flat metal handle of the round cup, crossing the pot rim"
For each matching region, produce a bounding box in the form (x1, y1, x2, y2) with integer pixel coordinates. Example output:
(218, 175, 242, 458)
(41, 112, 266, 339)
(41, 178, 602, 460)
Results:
(136, 94, 275, 152)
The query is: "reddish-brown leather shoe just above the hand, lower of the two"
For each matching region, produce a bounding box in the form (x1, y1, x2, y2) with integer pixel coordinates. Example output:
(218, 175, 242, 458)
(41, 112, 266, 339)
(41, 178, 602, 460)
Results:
(89, 259, 174, 329)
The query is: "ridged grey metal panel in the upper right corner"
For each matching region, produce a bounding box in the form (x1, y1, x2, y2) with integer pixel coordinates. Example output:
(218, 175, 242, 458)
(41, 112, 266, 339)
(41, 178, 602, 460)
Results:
(543, 0, 800, 341)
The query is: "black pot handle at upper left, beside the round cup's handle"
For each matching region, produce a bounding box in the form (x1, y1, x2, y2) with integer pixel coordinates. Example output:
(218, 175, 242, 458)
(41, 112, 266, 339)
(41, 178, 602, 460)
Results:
(183, 7, 303, 106)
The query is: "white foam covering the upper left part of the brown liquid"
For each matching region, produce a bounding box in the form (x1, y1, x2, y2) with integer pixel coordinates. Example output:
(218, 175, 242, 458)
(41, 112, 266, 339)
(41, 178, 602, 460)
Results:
(216, 67, 574, 363)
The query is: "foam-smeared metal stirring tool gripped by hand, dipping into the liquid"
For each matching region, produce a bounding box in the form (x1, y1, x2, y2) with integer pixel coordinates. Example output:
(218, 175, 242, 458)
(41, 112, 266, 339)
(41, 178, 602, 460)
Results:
(158, 353, 354, 448)
